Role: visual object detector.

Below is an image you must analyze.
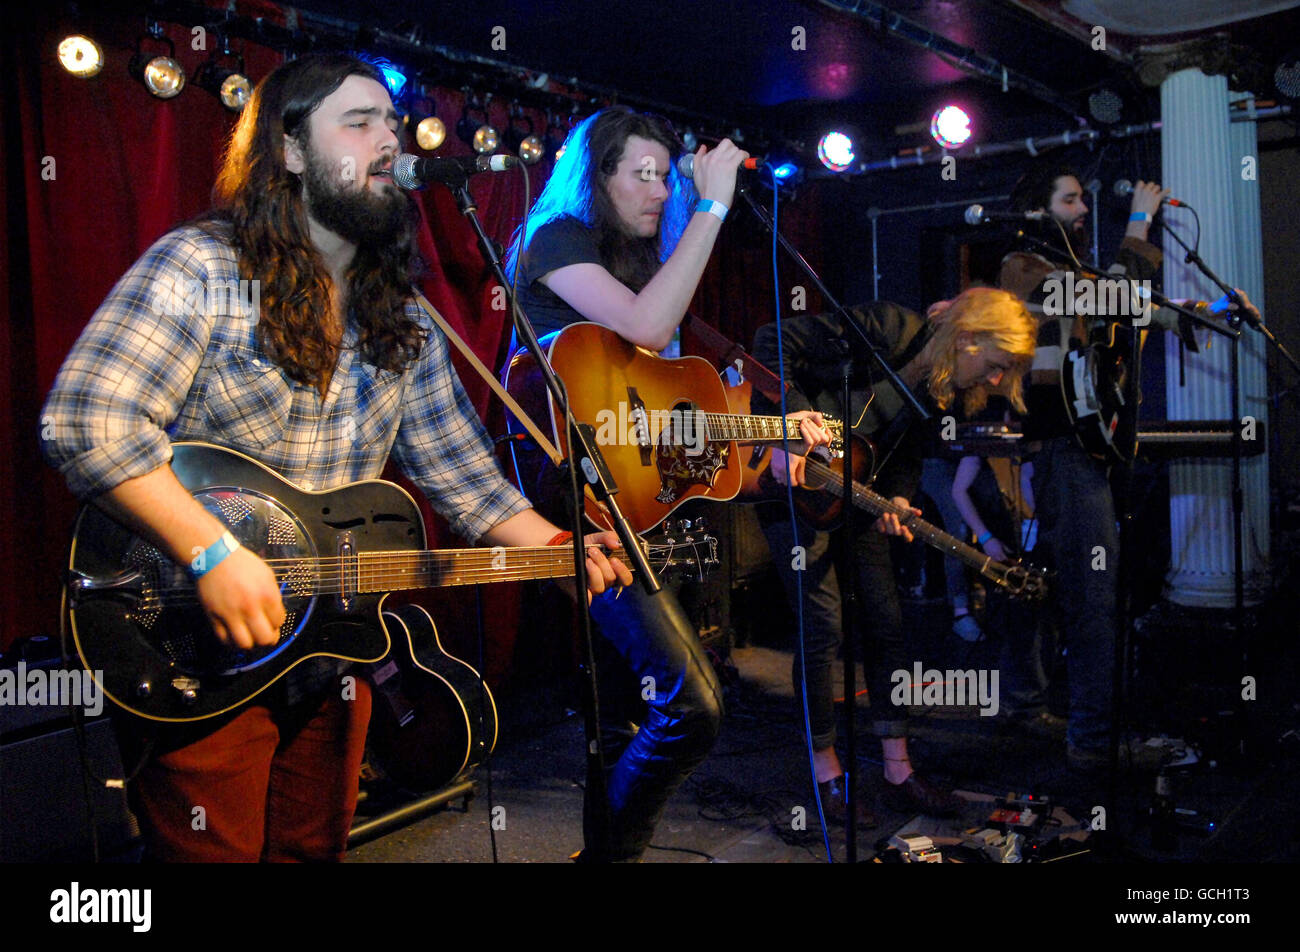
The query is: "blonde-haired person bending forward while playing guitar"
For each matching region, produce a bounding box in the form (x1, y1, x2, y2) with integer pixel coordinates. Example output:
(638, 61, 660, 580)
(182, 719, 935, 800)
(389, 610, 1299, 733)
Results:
(754, 287, 1036, 826)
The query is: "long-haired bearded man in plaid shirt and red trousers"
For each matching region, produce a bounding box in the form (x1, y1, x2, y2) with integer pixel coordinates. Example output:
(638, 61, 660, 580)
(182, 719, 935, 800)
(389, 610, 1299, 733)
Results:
(43, 53, 631, 861)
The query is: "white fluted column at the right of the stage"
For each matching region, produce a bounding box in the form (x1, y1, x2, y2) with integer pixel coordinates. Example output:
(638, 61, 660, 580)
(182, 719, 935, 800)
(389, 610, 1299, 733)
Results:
(1161, 69, 1269, 607)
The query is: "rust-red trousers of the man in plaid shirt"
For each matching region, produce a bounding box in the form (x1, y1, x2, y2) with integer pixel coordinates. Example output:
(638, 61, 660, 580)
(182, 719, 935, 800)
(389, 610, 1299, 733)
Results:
(121, 678, 371, 862)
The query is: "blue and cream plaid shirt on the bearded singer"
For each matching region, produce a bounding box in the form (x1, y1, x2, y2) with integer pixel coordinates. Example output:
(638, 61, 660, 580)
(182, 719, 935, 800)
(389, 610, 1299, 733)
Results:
(42, 228, 529, 697)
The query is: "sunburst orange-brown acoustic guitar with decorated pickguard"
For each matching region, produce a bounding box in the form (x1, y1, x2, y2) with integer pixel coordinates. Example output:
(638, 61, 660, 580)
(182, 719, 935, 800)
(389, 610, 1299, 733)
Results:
(504, 324, 844, 532)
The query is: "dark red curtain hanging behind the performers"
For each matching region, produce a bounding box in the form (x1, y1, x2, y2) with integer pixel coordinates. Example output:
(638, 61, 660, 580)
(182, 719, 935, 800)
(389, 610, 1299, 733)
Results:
(0, 13, 820, 681)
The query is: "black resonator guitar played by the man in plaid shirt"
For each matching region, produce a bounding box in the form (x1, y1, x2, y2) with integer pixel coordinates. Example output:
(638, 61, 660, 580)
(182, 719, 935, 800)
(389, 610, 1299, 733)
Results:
(66, 442, 696, 723)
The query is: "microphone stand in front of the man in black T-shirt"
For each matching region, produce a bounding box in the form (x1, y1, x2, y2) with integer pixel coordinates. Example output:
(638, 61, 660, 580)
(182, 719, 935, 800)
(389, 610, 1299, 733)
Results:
(736, 172, 931, 862)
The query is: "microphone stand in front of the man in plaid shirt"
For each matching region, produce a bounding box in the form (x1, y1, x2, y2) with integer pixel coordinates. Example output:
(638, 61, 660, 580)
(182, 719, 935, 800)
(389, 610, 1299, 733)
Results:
(447, 174, 663, 862)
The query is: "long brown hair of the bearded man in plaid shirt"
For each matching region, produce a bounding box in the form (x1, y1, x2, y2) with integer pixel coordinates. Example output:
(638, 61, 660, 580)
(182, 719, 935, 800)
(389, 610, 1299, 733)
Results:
(200, 53, 424, 388)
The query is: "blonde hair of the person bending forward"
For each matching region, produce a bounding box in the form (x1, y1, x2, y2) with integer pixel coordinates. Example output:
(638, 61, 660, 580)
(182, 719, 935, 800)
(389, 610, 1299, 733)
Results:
(927, 287, 1039, 414)
